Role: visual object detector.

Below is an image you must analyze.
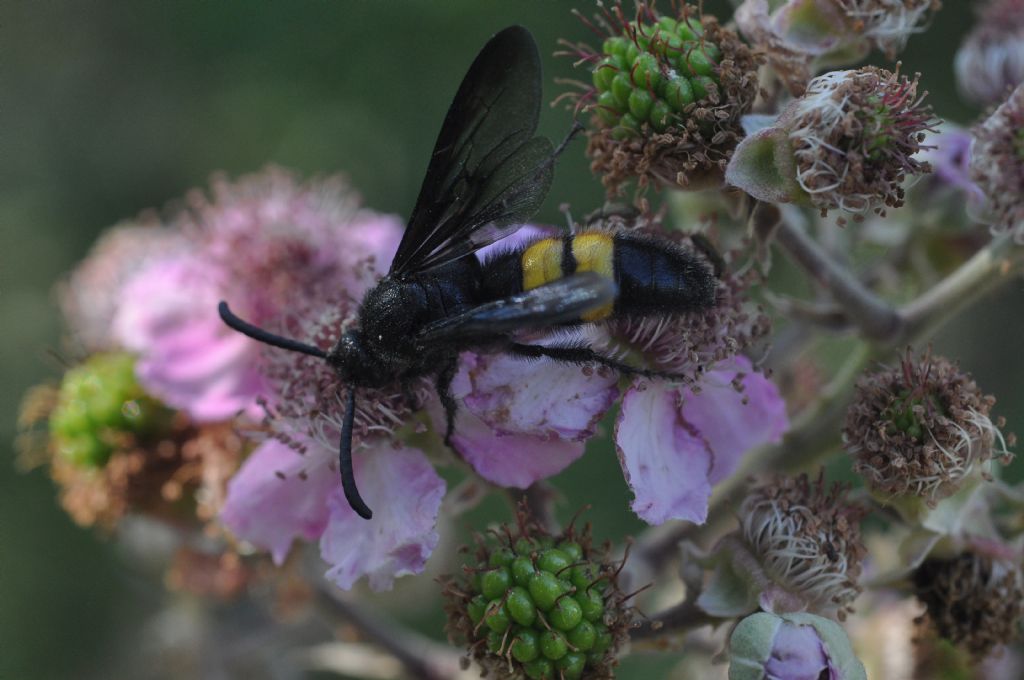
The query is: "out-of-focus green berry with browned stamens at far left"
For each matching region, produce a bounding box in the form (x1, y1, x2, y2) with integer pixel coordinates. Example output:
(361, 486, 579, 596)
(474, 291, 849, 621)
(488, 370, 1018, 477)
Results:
(18, 353, 244, 528)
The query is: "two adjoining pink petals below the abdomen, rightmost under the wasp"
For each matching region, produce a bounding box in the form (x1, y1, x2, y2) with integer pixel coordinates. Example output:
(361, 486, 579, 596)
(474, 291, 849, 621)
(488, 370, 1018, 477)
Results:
(615, 356, 788, 524)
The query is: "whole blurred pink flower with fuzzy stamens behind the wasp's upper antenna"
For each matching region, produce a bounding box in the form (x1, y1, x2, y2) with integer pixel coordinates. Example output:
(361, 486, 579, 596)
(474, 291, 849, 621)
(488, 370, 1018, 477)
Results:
(109, 168, 401, 421)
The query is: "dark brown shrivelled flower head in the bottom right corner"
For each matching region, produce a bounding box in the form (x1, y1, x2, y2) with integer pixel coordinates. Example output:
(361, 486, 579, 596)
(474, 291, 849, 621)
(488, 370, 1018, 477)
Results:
(913, 545, 1024, 658)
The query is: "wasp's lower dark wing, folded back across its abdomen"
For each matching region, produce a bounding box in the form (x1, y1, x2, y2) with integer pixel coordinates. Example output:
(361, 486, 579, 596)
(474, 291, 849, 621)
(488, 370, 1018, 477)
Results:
(417, 271, 616, 342)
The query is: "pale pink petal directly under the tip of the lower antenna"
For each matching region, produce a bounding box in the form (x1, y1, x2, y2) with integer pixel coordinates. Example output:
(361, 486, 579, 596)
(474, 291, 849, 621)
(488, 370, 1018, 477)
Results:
(321, 440, 444, 590)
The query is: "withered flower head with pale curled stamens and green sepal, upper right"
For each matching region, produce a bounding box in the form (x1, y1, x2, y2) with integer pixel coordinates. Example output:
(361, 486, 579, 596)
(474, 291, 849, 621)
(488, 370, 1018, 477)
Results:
(726, 67, 935, 221)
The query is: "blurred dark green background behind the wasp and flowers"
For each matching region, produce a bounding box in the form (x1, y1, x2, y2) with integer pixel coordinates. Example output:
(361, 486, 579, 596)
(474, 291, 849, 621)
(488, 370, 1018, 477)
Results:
(0, 0, 1024, 679)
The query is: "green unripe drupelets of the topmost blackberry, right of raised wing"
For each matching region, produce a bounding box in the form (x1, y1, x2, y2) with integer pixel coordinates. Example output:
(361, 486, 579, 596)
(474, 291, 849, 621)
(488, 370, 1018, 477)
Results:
(592, 16, 722, 138)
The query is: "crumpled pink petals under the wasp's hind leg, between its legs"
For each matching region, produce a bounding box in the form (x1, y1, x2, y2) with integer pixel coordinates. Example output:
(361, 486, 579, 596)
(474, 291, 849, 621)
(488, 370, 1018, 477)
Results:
(450, 352, 618, 488)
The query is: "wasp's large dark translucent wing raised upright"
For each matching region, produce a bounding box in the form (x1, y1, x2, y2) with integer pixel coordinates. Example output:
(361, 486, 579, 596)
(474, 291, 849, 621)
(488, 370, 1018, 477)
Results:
(391, 26, 554, 274)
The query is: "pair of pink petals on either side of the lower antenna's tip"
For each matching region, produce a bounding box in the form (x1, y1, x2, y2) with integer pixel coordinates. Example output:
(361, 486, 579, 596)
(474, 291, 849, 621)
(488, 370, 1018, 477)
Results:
(220, 438, 445, 590)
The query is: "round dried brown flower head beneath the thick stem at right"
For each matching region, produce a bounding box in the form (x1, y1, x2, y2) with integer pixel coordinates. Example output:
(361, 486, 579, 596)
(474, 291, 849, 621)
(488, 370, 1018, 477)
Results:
(843, 351, 1014, 505)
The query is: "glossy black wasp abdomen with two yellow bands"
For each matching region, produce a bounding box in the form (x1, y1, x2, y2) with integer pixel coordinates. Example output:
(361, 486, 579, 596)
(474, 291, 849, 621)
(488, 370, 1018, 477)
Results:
(481, 231, 715, 322)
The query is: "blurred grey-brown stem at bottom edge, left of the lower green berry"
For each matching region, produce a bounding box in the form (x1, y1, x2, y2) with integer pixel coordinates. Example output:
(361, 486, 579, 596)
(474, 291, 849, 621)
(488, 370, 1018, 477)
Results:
(316, 584, 459, 680)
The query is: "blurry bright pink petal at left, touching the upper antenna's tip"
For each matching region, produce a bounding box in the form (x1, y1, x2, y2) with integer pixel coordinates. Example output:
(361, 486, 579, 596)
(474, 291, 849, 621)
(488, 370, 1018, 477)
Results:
(114, 257, 262, 421)
